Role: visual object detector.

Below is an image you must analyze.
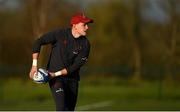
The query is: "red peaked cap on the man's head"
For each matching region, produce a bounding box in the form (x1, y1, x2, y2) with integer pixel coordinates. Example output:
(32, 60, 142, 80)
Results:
(71, 13, 93, 25)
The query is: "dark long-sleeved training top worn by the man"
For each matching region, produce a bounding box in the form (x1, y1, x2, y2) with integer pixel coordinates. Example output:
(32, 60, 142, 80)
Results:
(33, 28, 90, 80)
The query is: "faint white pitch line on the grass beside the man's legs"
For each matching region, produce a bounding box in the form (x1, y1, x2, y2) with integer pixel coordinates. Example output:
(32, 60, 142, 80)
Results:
(77, 101, 113, 110)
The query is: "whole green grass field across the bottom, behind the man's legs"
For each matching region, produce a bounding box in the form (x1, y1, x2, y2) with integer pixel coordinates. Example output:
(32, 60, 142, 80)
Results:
(0, 76, 180, 110)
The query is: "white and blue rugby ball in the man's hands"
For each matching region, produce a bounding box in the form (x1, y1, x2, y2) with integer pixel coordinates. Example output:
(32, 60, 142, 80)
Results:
(33, 68, 49, 83)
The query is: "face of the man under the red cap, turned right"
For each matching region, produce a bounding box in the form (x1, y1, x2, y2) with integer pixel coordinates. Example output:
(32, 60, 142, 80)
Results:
(74, 23, 88, 36)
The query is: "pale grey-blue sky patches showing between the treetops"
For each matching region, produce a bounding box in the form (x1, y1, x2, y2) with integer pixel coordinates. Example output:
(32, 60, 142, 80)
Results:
(0, 0, 177, 23)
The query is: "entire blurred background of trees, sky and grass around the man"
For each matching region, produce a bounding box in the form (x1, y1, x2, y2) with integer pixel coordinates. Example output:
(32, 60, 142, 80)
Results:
(0, 0, 180, 110)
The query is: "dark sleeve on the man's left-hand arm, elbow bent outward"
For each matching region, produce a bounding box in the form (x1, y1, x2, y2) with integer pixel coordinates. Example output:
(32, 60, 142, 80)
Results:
(32, 31, 57, 53)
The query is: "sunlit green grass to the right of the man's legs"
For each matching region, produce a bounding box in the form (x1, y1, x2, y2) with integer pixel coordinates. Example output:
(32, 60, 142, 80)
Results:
(79, 85, 180, 110)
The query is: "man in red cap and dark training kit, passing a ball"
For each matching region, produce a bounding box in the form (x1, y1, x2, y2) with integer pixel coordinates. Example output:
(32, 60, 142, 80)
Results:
(30, 14, 93, 111)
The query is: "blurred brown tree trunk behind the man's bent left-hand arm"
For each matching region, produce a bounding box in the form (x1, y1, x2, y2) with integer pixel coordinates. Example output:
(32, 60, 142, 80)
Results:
(30, 0, 51, 66)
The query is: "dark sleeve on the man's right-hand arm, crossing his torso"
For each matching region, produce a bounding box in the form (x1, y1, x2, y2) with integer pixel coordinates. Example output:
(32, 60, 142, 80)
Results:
(66, 41, 90, 74)
